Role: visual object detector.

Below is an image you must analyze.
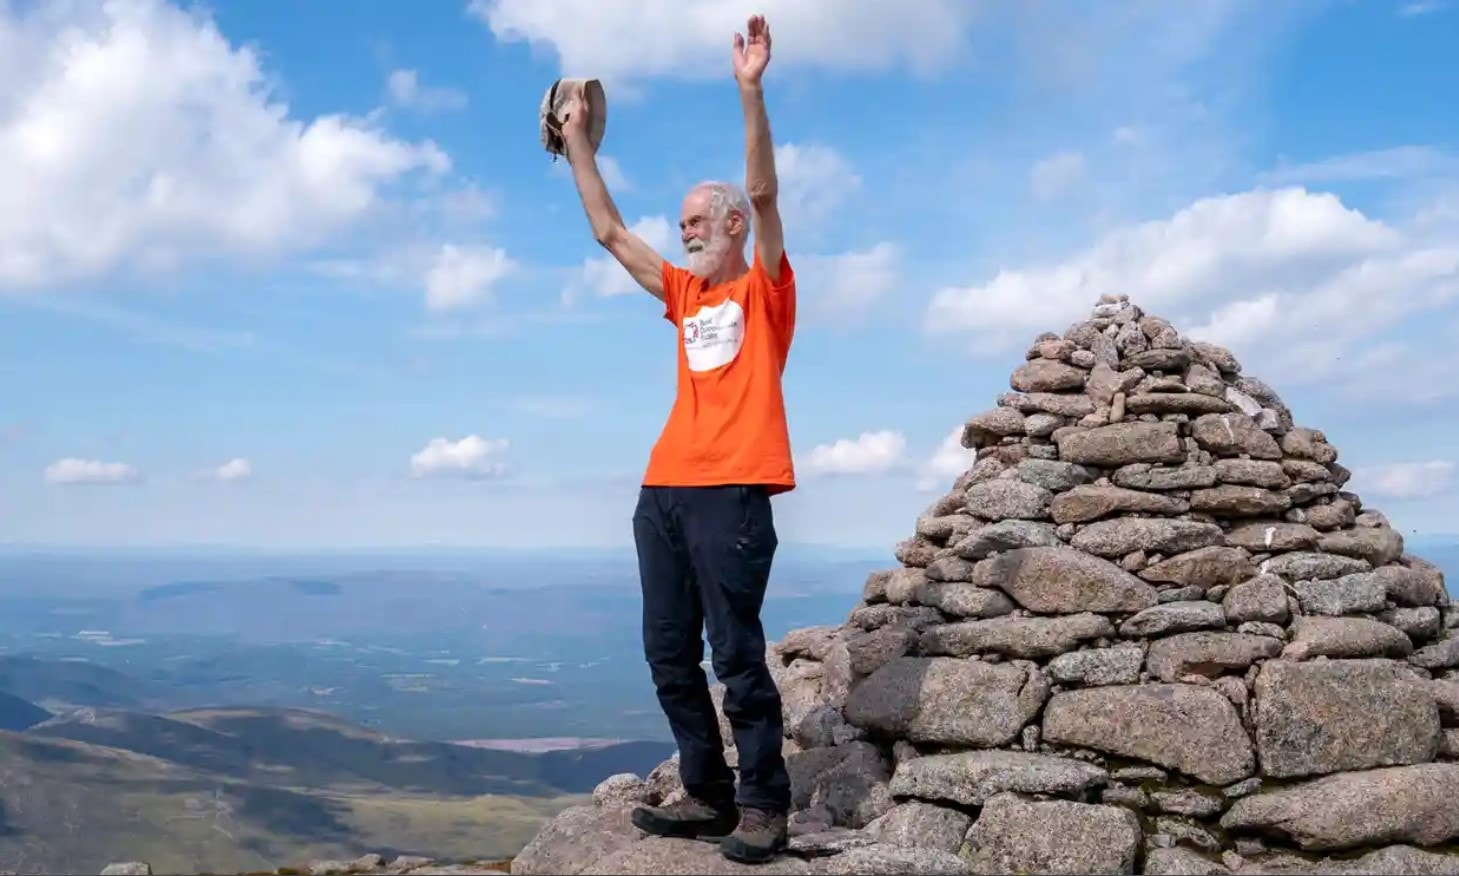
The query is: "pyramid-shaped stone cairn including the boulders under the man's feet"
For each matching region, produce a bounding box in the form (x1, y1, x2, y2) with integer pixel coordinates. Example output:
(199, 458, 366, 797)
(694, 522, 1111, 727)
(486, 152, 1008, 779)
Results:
(514, 296, 1459, 873)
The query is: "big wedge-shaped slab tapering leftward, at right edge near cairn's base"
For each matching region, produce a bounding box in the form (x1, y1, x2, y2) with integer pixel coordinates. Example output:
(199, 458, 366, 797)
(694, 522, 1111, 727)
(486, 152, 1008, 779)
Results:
(1221, 764, 1459, 851)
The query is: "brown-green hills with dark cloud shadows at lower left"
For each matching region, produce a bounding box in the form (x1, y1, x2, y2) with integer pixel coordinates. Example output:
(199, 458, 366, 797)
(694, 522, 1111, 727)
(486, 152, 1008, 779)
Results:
(0, 657, 673, 873)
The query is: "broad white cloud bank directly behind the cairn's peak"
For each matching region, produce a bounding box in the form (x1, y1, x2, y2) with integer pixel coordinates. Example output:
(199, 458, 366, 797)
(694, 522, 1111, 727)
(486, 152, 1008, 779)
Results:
(925, 188, 1459, 394)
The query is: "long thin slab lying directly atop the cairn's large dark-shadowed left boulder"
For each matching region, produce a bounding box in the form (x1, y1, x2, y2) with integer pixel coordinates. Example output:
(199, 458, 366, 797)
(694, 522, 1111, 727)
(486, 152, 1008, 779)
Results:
(919, 612, 1115, 660)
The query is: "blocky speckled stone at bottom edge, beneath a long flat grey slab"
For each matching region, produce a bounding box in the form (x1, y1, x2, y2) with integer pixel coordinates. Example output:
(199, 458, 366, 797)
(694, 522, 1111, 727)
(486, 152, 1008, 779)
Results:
(963, 794, 1141, 875)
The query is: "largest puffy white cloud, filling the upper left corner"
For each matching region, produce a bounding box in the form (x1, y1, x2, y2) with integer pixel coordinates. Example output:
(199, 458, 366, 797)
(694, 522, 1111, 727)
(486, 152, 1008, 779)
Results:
(0, 0, 449, 289)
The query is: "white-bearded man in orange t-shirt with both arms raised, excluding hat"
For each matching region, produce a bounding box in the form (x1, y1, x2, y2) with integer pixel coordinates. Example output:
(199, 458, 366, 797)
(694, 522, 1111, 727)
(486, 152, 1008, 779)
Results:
(551, 16, 795, 863)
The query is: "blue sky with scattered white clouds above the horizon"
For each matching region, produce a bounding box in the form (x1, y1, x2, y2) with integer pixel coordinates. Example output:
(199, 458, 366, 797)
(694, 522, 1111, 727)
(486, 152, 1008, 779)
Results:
(0, 0, 1459, 555)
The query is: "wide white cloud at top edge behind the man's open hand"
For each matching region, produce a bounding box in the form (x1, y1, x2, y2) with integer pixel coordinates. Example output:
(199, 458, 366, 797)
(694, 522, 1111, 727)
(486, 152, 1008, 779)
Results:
(470, 0, 979, 85)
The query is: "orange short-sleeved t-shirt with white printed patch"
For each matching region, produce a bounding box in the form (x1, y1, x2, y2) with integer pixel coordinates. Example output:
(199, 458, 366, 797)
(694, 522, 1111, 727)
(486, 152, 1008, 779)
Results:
(643, 253, 795, 493)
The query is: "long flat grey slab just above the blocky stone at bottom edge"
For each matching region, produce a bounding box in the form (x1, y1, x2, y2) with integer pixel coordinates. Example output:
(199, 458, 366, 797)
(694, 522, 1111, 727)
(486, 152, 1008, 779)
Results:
(891, 752, 1109, 806)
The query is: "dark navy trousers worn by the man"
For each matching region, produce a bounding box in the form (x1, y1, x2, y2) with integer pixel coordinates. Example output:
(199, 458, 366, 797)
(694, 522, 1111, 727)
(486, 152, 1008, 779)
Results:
(633, 485, 791, 812)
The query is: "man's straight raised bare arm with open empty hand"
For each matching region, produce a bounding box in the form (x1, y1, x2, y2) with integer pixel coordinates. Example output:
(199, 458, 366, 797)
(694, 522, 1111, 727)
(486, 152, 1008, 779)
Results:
(734, 15, 785, 282)
